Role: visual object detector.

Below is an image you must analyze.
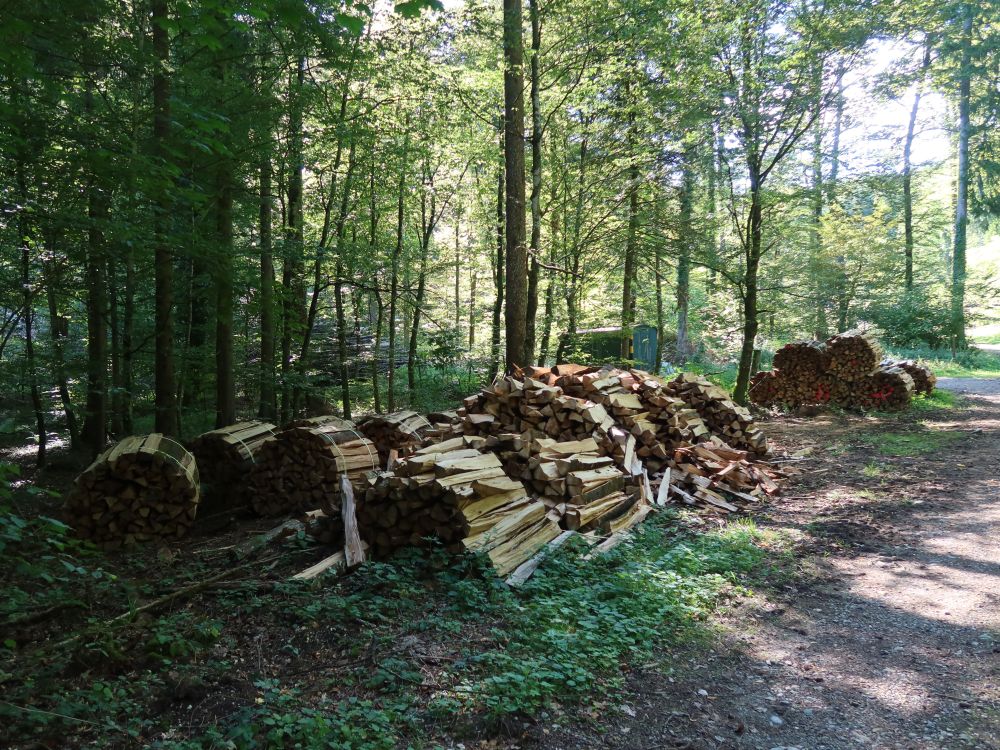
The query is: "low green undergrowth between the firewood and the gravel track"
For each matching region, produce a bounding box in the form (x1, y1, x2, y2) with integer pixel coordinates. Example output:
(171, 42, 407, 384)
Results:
(0, 496, 784, 750)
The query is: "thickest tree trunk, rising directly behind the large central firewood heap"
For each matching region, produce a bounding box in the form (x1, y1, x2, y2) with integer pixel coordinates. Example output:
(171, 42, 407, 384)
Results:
(503, 0, 529, 371)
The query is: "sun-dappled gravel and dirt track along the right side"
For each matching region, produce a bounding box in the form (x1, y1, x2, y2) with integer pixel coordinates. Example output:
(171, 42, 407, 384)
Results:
(522, 378, 1000, 750)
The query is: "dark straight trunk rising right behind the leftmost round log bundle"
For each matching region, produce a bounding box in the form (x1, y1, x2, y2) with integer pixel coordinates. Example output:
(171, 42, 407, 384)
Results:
(150, 0, 179, 435)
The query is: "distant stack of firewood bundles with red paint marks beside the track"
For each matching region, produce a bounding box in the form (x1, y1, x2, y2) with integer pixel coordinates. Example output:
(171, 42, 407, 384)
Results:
(752, 331, 936, 412)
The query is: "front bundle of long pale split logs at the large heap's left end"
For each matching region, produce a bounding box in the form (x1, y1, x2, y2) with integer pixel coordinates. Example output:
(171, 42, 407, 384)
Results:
(358, 446, 560, 575)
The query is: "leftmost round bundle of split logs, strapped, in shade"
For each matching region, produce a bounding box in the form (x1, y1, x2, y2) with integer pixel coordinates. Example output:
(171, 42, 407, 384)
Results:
(65, 433, 201, 546)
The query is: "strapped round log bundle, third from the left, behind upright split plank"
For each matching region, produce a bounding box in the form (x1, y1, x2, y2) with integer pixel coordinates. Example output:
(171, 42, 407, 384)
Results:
(247, 420, 378, 516)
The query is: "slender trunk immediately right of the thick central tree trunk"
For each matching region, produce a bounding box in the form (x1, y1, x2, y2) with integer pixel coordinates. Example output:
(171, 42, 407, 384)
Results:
(524, 0, 543, 364)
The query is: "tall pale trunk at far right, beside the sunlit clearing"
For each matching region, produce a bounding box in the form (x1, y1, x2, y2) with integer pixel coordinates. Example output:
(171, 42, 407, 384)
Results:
(951, 3, 974, 352)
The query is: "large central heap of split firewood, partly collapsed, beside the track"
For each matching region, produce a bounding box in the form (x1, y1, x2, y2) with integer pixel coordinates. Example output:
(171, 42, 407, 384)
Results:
(348, 365, 783, 574)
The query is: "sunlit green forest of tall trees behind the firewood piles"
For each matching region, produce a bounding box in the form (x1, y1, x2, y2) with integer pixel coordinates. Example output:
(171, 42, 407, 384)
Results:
(0, 0, 1000, 461)
